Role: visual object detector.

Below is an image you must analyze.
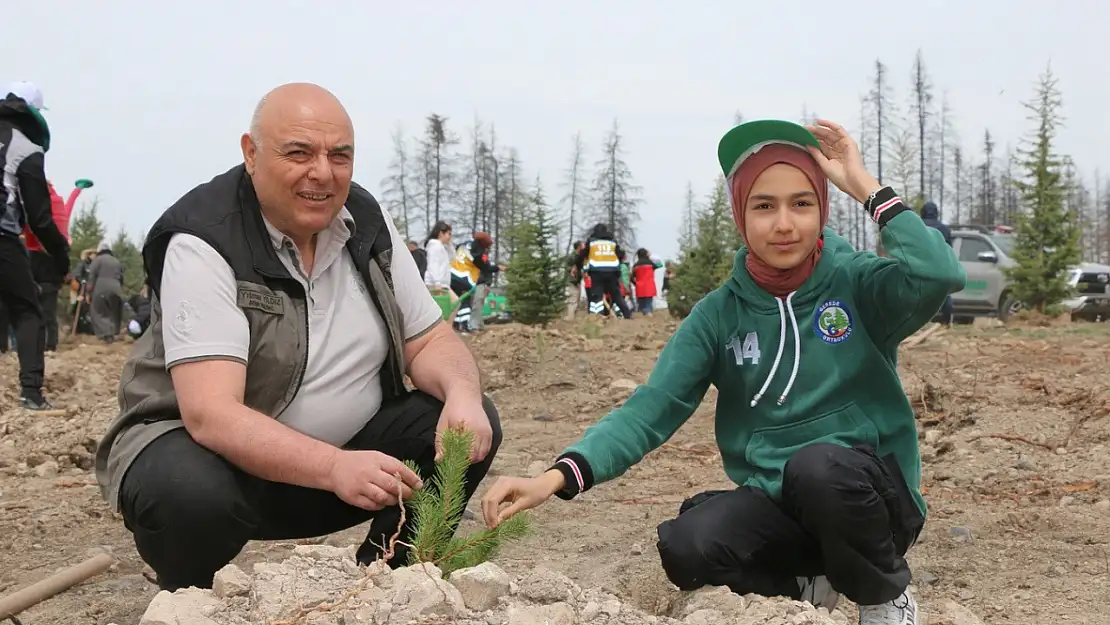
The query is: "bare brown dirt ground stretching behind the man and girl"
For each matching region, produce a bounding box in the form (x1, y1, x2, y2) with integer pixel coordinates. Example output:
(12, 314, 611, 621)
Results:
(0, 316, 1110, 625)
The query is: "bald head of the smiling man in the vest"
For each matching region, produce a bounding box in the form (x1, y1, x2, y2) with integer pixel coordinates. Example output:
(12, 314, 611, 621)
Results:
(240, 82, 354, 245)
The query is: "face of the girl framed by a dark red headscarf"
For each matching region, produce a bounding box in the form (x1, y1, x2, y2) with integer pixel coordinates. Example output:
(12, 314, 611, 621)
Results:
(744, 163, 821, 269)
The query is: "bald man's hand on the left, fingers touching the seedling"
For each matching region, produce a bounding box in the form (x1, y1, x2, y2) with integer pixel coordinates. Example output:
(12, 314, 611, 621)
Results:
(329, 450, 424, 511)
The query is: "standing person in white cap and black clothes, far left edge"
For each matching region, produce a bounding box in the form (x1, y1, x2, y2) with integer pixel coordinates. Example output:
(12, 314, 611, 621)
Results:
(0, 82, 69, 410)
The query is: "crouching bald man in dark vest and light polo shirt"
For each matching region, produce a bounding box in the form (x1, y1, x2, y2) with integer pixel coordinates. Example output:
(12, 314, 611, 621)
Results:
(95, 84, 501, 591)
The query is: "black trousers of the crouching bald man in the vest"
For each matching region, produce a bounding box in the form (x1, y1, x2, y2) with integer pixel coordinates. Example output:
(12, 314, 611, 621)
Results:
(120, 391, 501, 591)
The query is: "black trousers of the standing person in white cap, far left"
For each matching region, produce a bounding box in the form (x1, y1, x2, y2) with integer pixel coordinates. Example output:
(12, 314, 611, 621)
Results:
(0, 233, 46, 397)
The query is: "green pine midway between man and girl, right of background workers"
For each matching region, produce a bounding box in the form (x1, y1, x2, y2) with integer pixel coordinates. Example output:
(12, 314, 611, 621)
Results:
(507, 179, 566, 325)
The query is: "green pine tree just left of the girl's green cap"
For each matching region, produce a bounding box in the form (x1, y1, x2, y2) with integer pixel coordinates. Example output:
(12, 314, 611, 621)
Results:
(667, 177, 740, 317)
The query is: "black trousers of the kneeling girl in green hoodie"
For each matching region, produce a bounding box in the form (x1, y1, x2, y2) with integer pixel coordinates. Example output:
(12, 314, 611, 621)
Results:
(658, 443, 925, 605)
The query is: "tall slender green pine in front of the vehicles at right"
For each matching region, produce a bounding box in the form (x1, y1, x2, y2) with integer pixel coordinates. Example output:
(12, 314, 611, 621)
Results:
(1006, 68, 1081, 314)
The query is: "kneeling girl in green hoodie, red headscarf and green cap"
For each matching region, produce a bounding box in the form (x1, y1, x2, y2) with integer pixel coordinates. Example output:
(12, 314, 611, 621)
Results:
(483, 120, 966, 625)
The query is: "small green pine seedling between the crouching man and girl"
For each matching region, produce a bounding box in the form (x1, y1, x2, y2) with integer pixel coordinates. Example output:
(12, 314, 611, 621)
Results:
(405, 430, 531, 576)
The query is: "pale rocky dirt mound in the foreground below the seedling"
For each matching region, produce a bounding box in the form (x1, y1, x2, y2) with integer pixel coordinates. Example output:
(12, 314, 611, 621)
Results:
(140, 545, 848, 625)
